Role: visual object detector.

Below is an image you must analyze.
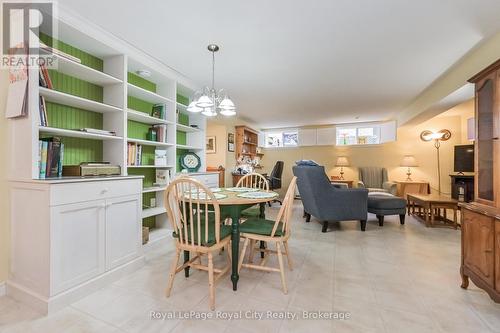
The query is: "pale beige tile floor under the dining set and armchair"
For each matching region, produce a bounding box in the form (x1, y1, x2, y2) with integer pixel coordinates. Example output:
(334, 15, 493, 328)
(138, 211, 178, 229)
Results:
(0, 203, 500, 333)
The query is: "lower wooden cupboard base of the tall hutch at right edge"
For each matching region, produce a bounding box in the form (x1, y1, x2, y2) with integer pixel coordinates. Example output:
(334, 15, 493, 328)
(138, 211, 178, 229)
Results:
(460, 204, 500, 302)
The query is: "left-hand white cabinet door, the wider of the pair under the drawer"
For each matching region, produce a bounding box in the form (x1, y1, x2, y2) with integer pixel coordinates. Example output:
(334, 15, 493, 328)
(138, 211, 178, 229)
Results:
(50, 200, 105, 295)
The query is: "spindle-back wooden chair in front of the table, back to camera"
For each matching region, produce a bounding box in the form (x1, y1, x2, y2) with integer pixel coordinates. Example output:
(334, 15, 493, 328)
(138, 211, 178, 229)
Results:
(164, 177, 231, 310)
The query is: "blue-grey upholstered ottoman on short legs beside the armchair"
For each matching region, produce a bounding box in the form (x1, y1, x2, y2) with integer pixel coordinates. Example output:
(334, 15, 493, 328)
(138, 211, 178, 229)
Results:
(368, 192, 406, 226)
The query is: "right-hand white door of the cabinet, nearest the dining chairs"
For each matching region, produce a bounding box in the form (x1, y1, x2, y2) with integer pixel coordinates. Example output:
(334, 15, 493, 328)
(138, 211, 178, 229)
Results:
(106, 195, 142, 270)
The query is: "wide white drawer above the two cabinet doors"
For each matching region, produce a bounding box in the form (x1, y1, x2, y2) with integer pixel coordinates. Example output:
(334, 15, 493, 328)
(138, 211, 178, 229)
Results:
(50, 179, 142, 206)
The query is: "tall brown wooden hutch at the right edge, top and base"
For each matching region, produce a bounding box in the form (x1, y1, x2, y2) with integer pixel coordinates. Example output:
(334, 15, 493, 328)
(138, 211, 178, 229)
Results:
(460, 60, 500, 302)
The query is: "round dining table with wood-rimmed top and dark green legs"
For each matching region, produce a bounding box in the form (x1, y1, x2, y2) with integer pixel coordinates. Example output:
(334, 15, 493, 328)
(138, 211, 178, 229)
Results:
(184, 188, 279, 291)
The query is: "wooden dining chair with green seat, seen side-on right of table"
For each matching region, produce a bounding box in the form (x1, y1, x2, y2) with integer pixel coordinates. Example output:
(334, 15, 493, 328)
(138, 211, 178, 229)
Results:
(238, 177, 297, 294)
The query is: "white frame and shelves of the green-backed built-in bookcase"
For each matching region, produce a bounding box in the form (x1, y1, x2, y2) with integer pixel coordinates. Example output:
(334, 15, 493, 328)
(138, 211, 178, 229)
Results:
(9, 8, 206, 244)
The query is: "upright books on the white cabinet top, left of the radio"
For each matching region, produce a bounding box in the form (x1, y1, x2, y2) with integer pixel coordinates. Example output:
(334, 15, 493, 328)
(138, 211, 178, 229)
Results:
(38, 137, 64, 179)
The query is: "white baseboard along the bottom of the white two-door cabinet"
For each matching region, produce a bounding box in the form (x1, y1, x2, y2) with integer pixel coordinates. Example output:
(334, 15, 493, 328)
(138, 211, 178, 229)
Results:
(6, 256, 145, 315)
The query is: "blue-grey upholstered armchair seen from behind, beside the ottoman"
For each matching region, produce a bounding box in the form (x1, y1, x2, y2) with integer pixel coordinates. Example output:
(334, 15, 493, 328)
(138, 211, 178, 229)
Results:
(293, 165, 368, 232)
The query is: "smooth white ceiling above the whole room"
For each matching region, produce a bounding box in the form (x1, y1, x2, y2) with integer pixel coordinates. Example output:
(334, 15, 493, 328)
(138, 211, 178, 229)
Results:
(59, 0, 500, 128)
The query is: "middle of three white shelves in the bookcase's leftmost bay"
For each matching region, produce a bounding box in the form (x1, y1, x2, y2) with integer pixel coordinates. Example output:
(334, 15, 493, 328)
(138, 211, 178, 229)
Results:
(39, 87, 123, 113)
